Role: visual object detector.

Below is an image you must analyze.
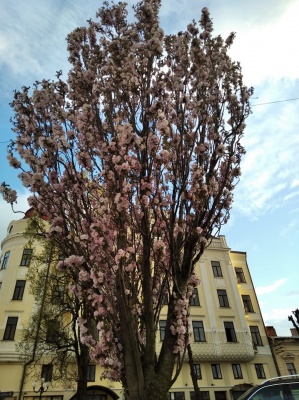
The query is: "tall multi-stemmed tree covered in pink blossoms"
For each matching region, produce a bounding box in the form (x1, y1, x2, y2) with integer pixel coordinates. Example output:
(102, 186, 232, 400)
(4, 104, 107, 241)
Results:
(1, 0, 253, 400)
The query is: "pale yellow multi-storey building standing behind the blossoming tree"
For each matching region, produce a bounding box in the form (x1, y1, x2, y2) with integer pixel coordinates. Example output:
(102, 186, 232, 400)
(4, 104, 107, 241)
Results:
(0, 218, 278, 400)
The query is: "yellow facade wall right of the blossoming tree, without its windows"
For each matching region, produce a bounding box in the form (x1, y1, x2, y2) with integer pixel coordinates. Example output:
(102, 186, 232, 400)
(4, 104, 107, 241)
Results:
(164, 236, 277, 400)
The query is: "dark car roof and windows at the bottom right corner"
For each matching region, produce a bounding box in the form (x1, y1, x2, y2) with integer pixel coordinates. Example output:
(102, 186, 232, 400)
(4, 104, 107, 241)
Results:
(238, 375, 299, 400)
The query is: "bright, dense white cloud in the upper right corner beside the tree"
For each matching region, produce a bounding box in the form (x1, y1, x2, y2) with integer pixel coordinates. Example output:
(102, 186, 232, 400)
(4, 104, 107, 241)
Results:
(232, 1, 299, 85)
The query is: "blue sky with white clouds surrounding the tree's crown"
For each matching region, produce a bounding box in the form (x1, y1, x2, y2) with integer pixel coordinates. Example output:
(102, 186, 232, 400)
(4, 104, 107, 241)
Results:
(0, 0, 299, 336)
